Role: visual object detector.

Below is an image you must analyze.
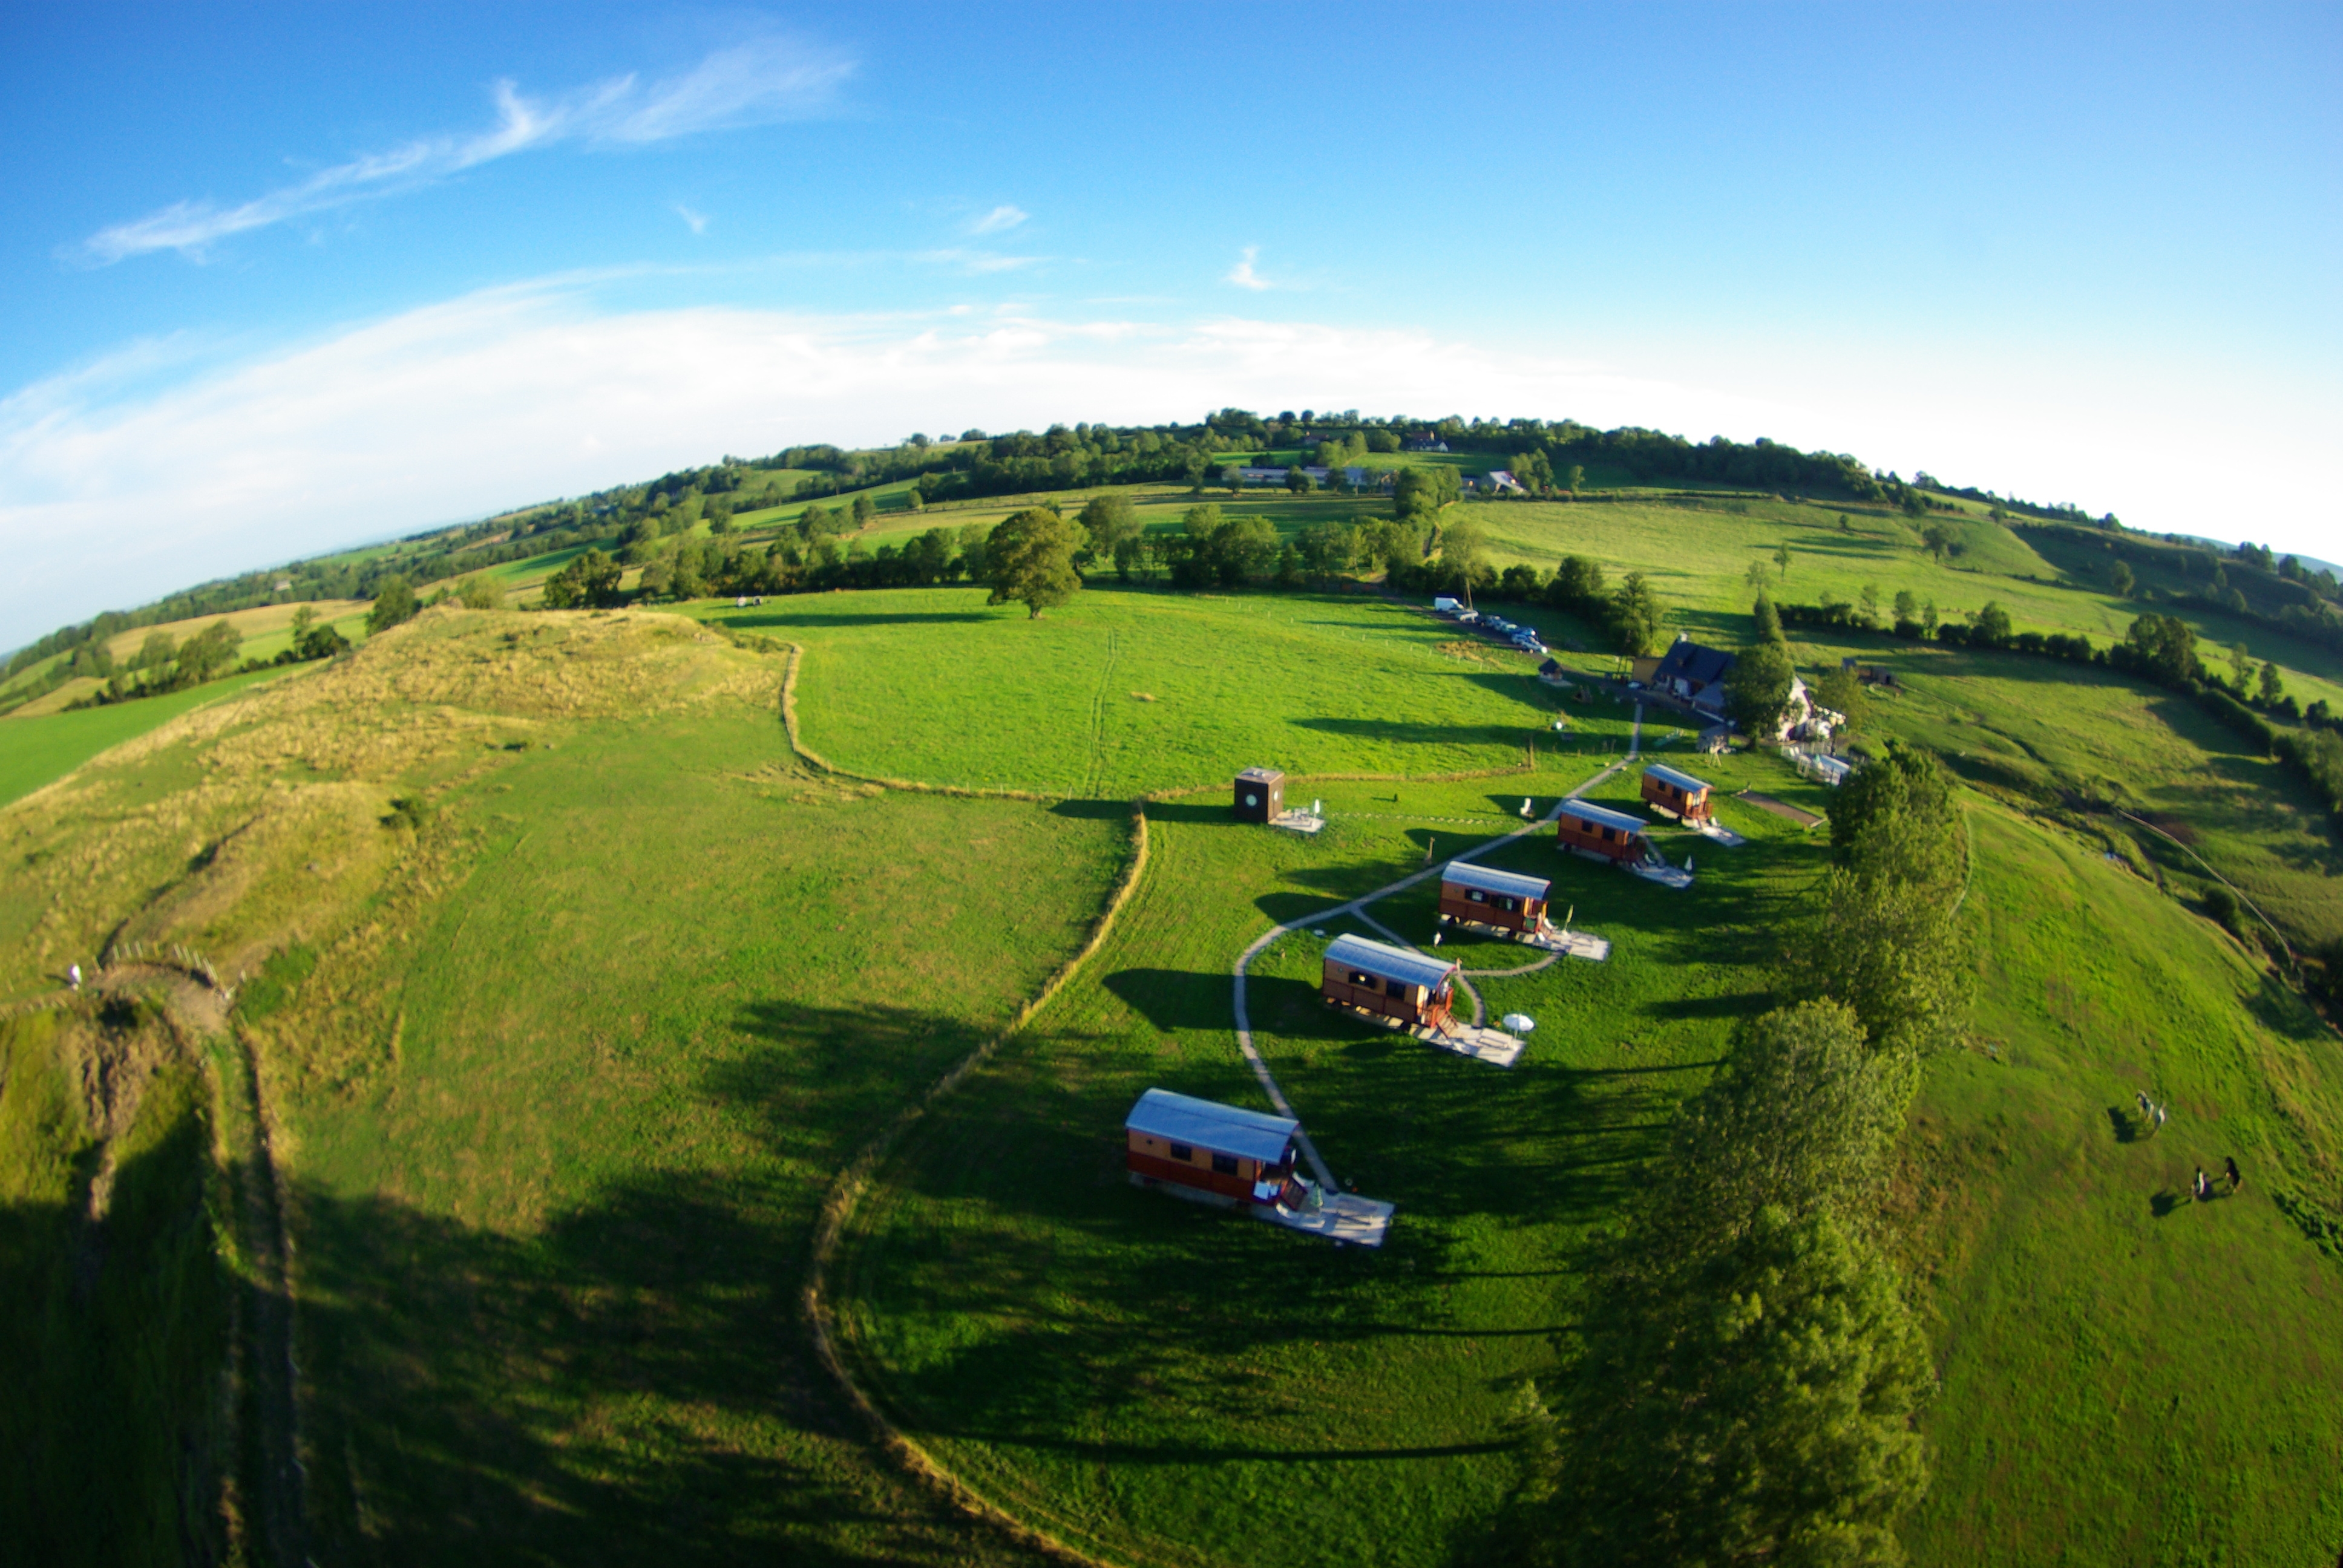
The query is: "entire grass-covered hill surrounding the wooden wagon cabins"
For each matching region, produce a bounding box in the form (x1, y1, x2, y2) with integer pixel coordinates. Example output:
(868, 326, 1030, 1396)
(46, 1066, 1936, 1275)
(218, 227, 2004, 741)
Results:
(13, 438, 2343, 1566)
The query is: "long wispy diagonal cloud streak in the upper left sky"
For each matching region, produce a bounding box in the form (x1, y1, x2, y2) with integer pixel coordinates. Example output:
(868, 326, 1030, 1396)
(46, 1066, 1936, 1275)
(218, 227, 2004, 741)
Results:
(64, 38, 855, 267)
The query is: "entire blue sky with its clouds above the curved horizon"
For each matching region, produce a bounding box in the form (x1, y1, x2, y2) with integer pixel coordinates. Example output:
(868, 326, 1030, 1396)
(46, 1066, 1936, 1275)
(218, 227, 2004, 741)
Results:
(0, 5, 2343, 647)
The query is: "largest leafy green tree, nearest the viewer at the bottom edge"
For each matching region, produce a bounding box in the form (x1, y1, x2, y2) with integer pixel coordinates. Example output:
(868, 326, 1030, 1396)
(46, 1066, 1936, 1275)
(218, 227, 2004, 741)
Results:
(1539, 1003, 1933, 1568)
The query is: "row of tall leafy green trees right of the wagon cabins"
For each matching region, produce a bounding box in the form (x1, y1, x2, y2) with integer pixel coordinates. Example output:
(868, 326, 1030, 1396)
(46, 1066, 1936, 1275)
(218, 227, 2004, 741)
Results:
(1507, 748, 1973, 1568)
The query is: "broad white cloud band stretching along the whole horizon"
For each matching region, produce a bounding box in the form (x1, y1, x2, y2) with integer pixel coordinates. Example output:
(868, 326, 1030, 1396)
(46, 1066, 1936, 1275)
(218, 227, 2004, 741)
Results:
(0, 279, 2338, 647)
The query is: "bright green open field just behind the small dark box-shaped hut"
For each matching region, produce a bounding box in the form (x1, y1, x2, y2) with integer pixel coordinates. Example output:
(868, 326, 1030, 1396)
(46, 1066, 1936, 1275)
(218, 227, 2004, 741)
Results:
(691, 588, 1602, 799)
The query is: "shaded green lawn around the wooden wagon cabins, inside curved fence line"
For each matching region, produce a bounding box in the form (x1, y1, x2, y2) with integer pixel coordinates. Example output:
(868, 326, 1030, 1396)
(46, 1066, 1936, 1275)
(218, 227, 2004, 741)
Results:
(844, 764, 1816, 1563)
